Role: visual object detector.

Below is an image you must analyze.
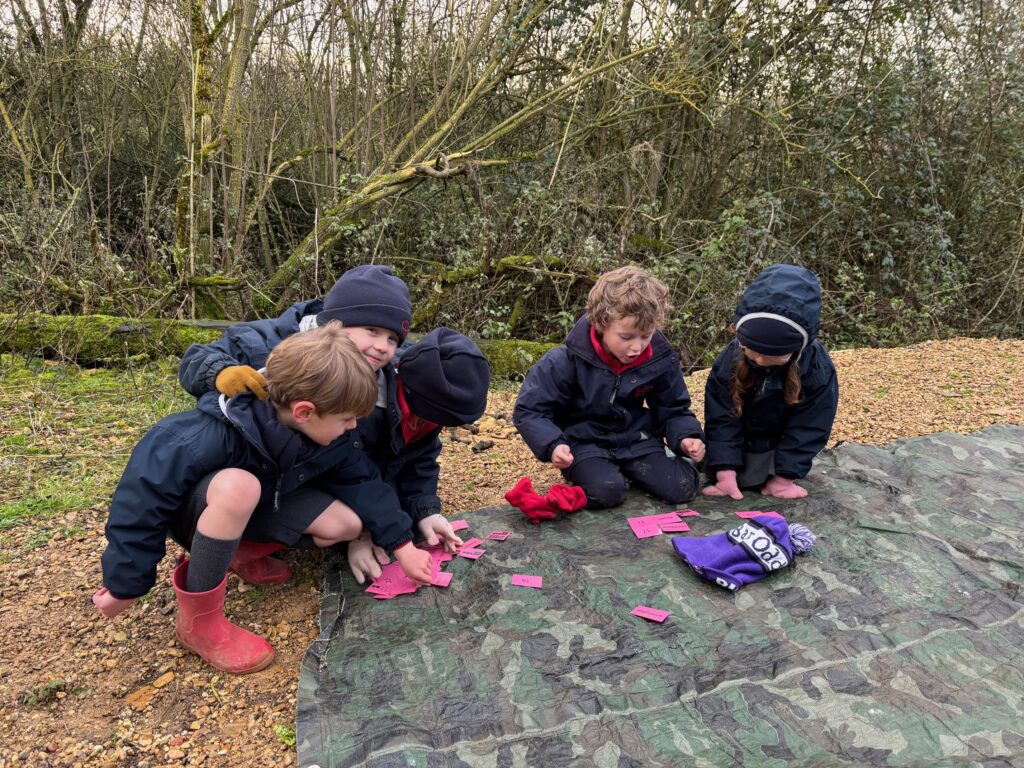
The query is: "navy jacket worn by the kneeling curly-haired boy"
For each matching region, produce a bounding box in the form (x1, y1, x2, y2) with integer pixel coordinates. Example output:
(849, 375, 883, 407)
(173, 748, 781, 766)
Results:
(512, 315, 703, 462)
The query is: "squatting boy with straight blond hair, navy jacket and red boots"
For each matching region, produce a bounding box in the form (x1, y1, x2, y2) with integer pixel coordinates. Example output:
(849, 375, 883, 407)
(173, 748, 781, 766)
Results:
(92, 323, 432, 674)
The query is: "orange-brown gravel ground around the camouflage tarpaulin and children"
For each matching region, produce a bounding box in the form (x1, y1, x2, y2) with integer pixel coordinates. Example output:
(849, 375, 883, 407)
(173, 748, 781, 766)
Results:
(0, 339, 1024, 768)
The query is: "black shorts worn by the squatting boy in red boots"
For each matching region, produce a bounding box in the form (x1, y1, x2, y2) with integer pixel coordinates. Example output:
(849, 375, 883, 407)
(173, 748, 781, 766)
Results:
(170, 470, 335, 549)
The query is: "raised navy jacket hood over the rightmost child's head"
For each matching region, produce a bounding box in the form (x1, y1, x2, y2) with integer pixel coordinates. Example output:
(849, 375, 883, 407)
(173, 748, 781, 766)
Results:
(732, 264, 821, 349)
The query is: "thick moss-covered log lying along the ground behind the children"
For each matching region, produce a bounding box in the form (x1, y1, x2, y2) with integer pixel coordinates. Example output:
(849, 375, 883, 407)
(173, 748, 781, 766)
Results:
(0, 312, 552, 379)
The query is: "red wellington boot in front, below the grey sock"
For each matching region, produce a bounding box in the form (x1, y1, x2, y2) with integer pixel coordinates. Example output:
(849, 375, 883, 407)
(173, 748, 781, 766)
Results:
(171, 560, 273, 675)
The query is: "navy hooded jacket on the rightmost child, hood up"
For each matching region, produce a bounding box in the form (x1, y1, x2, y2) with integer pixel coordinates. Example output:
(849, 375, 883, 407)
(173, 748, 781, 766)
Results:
(705, 264, 839, 479)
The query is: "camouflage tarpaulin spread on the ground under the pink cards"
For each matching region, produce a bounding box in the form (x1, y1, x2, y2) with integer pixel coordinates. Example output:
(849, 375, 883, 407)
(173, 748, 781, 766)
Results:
(297, 427, 1024, 768)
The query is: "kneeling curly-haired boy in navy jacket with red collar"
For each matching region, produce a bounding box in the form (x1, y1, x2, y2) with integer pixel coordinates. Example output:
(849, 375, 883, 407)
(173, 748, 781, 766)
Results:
(513, 266, 705, 508)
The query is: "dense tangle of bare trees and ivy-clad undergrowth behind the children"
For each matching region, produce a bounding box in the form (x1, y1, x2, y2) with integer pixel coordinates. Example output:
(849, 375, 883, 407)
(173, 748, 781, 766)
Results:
(0, 0, 1024, 359)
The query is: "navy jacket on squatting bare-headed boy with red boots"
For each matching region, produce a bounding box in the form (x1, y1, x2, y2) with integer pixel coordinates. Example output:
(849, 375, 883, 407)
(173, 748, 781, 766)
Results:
(102, 392, 412, 598)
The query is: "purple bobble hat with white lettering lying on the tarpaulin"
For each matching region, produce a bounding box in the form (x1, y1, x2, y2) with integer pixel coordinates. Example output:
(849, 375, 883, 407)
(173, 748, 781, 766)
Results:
(672, 515, 814, 590)
